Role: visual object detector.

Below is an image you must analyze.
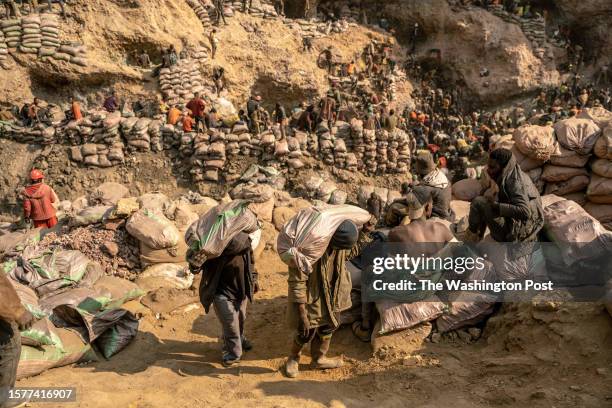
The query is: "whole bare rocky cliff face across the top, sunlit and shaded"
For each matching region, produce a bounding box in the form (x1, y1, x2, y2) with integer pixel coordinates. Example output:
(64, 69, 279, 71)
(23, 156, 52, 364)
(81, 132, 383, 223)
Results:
(0, 0, 612, 106)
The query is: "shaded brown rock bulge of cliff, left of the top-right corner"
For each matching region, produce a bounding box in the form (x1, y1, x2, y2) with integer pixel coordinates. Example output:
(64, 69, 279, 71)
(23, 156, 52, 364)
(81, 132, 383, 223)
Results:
(385, 0, 560, 104)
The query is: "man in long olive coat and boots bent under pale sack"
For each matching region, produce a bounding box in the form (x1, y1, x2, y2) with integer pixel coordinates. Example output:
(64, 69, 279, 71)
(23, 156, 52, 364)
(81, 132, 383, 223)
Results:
(285, 221, 374, 378)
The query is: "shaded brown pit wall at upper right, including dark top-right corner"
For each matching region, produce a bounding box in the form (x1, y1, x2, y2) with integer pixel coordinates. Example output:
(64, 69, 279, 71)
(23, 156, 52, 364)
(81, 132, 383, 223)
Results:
(310, 0, 612, 108)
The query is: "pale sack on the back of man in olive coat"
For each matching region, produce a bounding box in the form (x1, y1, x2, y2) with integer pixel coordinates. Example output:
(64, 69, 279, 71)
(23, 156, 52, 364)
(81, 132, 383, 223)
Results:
(276, 204, 371, 274)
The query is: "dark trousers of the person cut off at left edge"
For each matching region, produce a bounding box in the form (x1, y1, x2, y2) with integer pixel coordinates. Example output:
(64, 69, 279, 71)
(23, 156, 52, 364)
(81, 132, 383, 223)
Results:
(0, 320, 21, 408)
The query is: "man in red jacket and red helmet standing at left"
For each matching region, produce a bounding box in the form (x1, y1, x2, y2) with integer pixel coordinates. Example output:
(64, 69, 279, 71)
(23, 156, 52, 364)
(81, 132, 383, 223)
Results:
(22, 169, 59, 228)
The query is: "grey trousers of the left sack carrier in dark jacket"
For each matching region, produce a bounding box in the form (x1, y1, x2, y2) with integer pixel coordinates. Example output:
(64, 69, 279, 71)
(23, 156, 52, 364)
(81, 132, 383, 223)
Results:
(213, 295, 248, 360)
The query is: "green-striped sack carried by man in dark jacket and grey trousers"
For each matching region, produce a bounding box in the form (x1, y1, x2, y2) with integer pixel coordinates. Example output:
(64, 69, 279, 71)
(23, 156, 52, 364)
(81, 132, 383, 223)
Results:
(185, 200, 259, 268)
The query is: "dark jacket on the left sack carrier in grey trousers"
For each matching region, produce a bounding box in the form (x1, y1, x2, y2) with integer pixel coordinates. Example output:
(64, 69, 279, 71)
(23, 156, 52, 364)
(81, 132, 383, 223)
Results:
(200, 232, 257, 313)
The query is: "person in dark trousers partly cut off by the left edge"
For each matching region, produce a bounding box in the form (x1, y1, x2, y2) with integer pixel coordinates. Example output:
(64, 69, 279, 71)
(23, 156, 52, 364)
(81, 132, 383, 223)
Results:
(0, 273, 34, 408)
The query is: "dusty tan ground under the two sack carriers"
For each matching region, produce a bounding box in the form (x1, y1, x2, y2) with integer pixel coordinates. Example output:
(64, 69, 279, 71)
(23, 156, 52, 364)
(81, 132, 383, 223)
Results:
(18, 252, 612, 408)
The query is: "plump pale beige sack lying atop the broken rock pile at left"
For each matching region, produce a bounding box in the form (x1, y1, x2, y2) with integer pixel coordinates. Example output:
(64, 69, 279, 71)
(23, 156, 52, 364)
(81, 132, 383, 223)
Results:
(125, 209, 181, 249)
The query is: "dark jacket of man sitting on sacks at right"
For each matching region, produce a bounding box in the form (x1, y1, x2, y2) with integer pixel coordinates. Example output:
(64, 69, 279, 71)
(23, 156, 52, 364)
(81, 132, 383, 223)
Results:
(493, 157, 544, 242)
